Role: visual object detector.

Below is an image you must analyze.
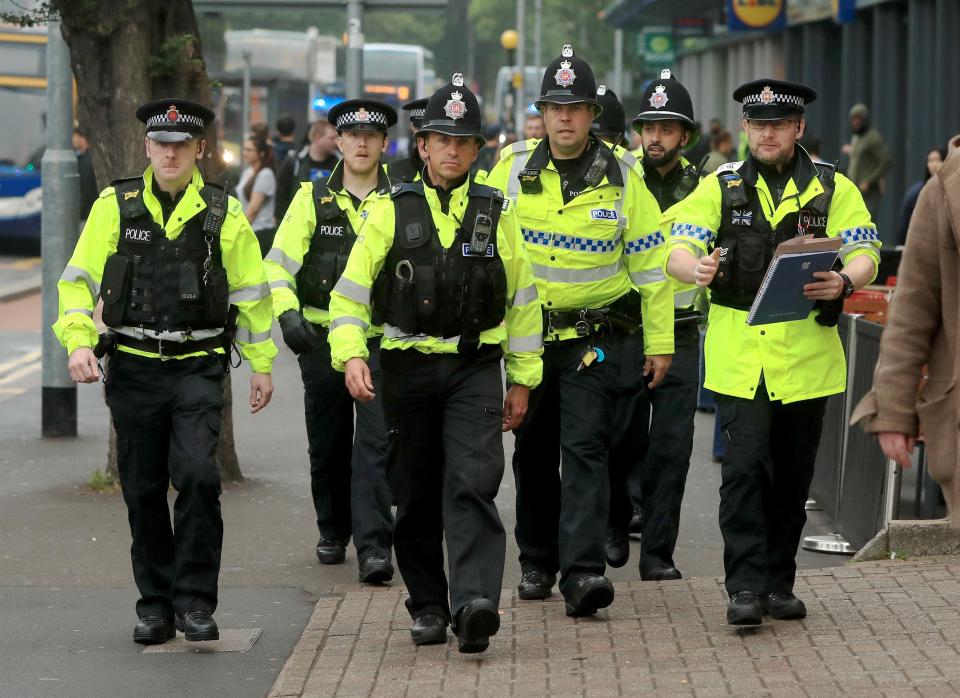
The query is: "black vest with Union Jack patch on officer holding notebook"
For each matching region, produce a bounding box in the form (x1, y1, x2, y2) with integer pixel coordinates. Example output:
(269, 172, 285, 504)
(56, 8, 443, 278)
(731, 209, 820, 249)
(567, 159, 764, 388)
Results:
(710, 163, 835, 310)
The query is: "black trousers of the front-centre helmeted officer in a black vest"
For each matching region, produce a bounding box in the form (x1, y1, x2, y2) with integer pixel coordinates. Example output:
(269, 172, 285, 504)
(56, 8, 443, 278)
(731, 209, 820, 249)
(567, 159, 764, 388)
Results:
(381, 347, 506, 620)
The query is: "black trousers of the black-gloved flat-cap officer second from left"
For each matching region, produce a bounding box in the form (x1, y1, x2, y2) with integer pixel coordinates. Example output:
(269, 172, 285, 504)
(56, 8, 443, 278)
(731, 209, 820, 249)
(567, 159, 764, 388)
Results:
(299, 332, 393, 561)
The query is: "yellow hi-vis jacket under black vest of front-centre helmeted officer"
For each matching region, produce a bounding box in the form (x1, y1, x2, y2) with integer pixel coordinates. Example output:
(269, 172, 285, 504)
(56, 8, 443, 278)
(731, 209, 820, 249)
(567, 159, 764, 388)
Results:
(329, 177, 543, 388)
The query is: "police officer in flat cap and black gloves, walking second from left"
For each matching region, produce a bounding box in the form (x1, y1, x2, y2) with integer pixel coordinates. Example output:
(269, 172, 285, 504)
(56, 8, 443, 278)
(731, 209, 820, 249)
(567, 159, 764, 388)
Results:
(264, 99, 397, 584)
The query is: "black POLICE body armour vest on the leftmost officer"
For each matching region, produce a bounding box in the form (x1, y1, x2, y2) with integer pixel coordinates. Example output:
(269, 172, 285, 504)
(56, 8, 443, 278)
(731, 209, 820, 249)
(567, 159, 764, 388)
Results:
(100, 177, 230, 334)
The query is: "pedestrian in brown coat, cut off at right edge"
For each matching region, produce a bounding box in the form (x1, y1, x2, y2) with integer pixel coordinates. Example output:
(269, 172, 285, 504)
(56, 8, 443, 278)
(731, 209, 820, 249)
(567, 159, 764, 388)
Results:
(851, 136, 960, 528)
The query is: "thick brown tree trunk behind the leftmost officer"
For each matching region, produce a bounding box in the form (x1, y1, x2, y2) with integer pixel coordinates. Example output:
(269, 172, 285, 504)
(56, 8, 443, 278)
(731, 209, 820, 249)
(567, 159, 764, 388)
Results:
(51, 0, 243, 480)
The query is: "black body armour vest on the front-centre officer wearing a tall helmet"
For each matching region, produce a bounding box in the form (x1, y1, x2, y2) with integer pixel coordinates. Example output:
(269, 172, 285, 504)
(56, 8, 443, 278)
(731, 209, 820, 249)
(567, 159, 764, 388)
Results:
(373, 182, 507, 351)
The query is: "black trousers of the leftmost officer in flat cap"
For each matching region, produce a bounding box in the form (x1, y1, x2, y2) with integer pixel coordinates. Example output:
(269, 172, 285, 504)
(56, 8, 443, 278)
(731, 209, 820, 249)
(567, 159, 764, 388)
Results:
(106, 351, 224, 617)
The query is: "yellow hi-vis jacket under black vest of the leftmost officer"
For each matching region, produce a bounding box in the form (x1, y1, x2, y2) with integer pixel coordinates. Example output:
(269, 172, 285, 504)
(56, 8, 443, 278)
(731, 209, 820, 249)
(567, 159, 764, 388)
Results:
(53, 167, 277, 373)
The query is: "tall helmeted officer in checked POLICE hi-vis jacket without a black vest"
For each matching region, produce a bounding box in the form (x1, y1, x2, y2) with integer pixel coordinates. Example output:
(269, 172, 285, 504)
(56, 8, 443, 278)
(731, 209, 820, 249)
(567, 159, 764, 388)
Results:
(488, 45, 673, 616)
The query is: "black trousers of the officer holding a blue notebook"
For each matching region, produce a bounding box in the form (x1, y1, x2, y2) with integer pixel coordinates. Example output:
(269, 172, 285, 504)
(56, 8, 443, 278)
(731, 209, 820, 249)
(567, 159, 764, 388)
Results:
(716, 381, 827, 594)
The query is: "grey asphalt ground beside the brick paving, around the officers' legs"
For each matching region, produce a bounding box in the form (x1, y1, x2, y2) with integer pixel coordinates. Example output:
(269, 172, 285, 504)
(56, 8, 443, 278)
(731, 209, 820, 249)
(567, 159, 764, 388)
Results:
(0, 282, 846, 698)
